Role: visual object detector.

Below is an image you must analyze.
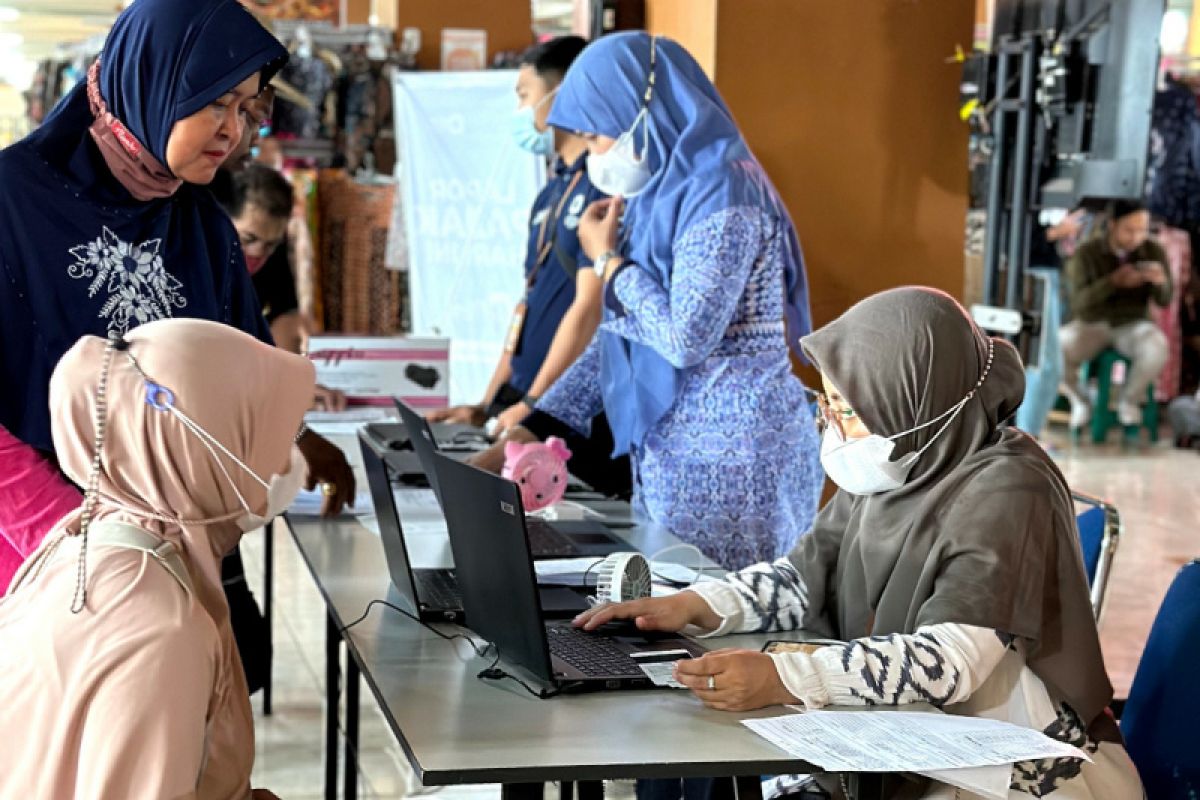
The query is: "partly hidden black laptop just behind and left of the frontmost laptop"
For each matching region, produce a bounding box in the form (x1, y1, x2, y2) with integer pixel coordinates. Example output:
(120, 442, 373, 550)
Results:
(359, 432, 463, 625)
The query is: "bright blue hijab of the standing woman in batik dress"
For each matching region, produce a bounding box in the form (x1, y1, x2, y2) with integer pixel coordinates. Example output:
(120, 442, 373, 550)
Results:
(550, 32, 811, 455)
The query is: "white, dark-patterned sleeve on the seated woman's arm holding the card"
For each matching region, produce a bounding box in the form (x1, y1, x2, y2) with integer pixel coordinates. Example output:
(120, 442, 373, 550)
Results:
(770, 622, 1013, 709)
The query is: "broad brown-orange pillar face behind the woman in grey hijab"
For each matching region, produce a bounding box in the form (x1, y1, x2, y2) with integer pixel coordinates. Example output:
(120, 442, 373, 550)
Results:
(716, 0, 974, 325)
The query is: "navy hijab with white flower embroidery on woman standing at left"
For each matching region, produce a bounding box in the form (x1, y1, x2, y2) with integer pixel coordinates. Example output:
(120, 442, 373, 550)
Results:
(0, 0, 287, 451)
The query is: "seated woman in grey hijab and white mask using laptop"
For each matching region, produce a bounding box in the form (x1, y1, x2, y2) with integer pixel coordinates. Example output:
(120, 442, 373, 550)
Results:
(577, 288, 1142, 800)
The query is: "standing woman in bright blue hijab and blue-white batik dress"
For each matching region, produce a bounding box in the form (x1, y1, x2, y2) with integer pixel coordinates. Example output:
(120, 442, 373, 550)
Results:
(492, 32, 823, 569)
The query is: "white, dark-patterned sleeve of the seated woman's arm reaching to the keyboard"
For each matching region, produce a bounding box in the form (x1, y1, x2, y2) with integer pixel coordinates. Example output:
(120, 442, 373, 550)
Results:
(689, 558, 809, 636)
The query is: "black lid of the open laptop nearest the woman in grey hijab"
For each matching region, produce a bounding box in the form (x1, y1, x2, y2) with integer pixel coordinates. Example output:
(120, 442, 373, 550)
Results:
(433, 453, 553, 682)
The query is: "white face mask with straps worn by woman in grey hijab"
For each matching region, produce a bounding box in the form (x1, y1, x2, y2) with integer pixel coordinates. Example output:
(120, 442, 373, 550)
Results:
(821, 342, 995, 495)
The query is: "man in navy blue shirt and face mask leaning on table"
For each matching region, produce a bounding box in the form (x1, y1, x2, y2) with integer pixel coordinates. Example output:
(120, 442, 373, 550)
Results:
(430, 36, 630, 495)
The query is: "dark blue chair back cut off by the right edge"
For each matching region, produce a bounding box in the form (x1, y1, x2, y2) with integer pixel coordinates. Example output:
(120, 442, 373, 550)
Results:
(1121, 559, 1200, 800)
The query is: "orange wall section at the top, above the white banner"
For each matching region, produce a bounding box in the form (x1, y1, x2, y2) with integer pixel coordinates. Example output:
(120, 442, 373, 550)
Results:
(384, 0, 533, 70)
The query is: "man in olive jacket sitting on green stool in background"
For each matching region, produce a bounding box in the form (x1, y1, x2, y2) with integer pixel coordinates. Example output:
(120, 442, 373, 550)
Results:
(1058, 200, 1171, 428)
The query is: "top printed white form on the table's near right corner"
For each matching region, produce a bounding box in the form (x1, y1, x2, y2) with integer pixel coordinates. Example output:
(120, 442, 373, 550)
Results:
(742, 711, 1087, 772)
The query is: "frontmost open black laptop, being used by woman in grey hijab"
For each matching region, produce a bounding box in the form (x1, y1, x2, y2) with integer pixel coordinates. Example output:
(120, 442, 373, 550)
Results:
(434, 455, 704, 691)
